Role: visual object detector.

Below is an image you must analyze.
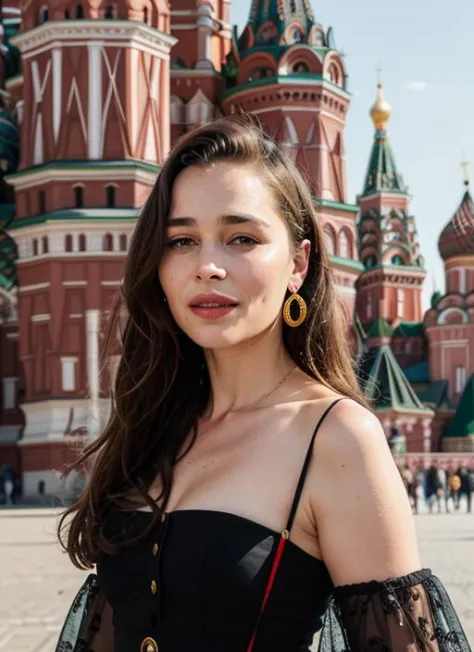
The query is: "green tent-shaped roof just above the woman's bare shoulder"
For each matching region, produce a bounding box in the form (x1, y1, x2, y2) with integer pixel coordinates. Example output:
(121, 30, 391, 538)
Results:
(358, 344, 431, 414)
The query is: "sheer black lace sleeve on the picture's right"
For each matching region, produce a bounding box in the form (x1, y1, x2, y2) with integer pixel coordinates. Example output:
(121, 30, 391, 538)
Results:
(319, 570, 471, 652)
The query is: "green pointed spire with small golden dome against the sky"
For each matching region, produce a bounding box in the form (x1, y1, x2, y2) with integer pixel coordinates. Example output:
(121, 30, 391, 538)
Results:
(362, 82, 407, 197)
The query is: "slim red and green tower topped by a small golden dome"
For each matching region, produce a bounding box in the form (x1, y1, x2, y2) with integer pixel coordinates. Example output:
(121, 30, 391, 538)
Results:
(356, 83, 426, 332)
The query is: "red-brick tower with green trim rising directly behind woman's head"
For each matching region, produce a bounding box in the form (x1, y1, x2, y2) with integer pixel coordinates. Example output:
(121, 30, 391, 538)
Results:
(221, 0, 361, 318)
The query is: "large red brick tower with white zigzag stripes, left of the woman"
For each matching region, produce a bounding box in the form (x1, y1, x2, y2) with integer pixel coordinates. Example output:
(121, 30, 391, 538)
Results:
(2, 0, 175, 495)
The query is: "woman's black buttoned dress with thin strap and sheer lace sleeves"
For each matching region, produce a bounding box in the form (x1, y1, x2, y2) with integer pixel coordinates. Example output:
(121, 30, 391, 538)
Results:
(56, 403, 470, 652)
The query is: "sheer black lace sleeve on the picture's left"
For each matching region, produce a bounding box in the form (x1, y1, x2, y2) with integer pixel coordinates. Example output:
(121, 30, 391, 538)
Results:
(55, 574, 114, 652)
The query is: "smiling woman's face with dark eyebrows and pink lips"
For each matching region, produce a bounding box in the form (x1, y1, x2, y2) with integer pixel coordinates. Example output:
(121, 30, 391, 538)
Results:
(159, 162, 310, 349)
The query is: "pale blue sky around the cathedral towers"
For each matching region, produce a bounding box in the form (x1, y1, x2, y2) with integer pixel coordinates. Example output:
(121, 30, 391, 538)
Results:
(232, 0, 474, 308)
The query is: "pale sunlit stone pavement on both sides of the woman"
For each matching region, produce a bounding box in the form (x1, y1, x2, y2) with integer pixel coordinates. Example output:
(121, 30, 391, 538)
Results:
(0, 509, 474, 652)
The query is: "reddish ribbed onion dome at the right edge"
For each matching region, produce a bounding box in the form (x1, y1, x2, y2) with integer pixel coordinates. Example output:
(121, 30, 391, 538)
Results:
(438, 181, 474, 260)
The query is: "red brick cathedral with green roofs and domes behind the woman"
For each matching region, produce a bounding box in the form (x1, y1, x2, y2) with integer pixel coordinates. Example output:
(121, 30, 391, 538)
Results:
(0, 0, 474, 497)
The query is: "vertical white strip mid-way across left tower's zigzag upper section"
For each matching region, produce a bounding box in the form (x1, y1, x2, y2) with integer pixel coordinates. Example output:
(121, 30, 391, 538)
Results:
(87, 43, 102, 159)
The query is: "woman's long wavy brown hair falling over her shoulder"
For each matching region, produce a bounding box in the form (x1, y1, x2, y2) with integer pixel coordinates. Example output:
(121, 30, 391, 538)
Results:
(59, 116, 365, 568)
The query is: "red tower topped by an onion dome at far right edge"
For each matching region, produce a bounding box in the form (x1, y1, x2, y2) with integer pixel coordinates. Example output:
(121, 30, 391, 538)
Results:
(425, 168, 474, 412)
